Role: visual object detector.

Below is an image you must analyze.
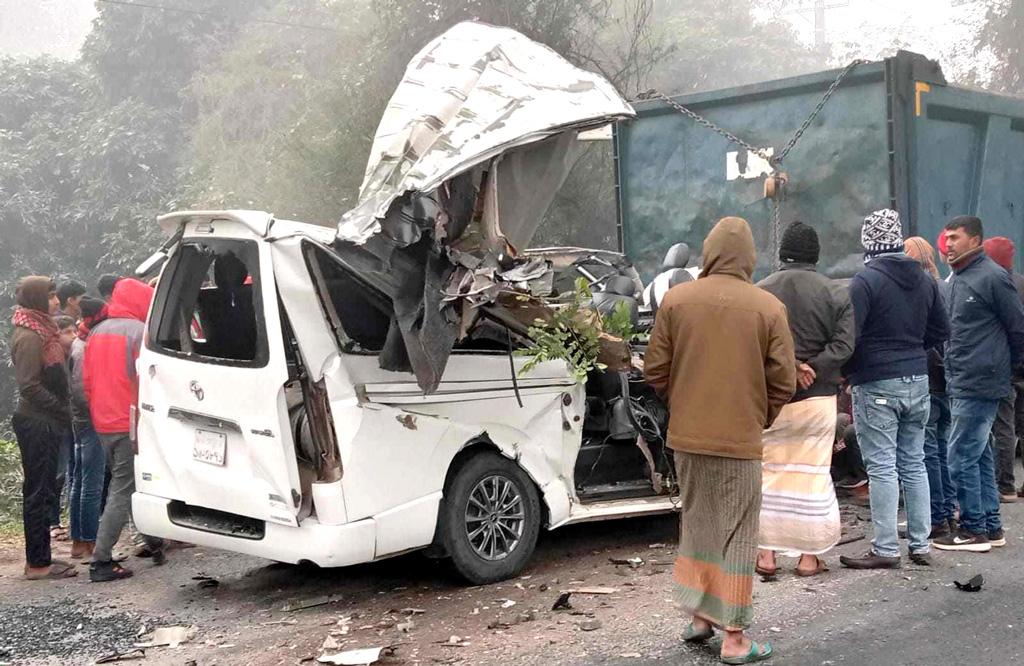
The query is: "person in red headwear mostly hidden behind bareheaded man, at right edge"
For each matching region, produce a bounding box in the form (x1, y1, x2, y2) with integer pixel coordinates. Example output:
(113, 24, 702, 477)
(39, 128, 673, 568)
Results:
(982, 236, 1024, 504)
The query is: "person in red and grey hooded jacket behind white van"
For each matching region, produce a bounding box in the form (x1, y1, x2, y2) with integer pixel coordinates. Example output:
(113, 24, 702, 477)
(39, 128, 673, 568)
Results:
(82, 279, 164, 583)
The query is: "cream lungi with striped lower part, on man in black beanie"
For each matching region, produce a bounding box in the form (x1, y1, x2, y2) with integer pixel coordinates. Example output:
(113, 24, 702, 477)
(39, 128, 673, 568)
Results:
(758, 396, 842, 555)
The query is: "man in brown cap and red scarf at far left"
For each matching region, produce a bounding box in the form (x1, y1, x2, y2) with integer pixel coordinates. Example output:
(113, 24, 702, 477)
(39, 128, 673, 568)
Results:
(10, 276, 76, 580)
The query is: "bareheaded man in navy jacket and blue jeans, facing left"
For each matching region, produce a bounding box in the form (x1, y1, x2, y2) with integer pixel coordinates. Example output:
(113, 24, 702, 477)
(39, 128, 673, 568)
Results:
(935, 215, 1024, 552)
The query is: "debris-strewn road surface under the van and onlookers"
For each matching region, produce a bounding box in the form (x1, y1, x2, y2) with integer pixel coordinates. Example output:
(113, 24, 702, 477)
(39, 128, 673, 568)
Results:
(6, 474, 1024, 666)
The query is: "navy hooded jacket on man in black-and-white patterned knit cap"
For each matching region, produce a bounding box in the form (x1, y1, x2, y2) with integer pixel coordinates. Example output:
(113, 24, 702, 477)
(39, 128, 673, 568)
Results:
(843, 252, 949, 386)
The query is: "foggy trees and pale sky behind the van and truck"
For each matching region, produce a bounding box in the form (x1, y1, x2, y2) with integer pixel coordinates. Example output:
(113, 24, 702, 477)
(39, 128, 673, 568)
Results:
(0, 0, 1024, 418)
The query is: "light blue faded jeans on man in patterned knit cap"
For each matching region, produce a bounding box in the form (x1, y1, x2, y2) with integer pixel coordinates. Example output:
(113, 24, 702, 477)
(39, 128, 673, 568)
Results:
(853, 376, 932, 557)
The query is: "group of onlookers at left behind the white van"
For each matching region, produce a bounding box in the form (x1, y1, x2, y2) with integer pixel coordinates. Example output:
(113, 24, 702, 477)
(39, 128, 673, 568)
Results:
(10, 276, 164, 582)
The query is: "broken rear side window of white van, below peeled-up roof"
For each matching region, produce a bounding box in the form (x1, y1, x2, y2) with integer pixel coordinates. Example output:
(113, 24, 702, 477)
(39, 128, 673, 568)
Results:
(305, 244, 392, 353)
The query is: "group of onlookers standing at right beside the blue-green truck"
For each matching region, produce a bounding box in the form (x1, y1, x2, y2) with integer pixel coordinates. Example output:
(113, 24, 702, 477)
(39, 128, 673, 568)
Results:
(644, 209, 1024, 664)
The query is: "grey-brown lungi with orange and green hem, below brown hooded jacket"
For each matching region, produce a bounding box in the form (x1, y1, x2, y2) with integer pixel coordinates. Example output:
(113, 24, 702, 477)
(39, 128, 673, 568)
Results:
(673, 451, 761, 631)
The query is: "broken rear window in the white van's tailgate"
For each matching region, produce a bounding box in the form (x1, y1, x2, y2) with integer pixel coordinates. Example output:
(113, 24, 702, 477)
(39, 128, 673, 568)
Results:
(148, 239, 268, 367)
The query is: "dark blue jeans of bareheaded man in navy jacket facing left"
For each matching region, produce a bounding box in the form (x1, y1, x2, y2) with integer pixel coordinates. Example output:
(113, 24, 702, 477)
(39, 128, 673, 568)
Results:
(949, 398, 1002, 534)
